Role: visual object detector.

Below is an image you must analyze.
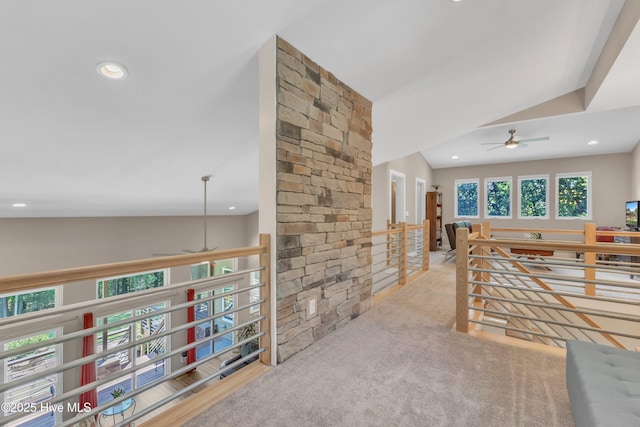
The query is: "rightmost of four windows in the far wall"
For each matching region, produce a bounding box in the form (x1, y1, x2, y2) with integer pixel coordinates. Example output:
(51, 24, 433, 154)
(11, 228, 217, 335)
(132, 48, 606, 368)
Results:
(556, 172, 591, 219)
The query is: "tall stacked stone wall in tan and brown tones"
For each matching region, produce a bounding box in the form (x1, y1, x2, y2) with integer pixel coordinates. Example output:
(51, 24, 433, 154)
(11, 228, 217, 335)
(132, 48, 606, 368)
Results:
(276, 38, 372, 361)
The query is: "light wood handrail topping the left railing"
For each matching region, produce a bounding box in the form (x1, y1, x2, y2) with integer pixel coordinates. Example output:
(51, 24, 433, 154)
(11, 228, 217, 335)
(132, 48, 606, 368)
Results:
(0, 245, 267, 293)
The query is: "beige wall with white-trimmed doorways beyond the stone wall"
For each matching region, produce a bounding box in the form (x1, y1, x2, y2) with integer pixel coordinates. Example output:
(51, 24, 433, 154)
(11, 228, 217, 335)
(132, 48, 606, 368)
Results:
(371, 153, 436, 231)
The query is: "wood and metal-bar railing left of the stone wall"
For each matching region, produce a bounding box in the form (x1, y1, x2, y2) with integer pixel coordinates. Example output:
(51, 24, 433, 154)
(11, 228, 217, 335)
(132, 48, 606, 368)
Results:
(0, 235, 271, 426)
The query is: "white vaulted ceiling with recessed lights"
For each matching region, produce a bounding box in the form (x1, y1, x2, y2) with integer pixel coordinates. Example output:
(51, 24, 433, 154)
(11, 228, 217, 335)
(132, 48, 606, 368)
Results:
(0, 0, 640, 217)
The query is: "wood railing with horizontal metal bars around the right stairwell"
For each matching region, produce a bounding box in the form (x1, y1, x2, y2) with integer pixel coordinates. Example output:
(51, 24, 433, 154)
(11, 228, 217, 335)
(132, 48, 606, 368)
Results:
(456, 223, 640, 349)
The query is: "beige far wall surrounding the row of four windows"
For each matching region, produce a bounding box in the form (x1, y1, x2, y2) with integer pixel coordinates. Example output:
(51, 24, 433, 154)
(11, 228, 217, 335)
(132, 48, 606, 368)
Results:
(434, 154, 634, 242)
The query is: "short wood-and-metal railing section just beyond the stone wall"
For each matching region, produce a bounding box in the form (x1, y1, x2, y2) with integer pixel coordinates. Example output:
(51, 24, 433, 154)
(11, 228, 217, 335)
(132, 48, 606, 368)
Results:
(371, 220, 429, 294)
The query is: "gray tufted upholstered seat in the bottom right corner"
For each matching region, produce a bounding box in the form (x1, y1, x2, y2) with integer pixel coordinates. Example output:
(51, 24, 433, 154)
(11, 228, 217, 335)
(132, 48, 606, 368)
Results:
(566, 341, 640, 427)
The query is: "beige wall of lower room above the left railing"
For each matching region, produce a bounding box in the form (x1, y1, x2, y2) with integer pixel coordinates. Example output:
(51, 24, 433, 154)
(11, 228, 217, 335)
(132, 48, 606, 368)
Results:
(0, 213, 257, 276)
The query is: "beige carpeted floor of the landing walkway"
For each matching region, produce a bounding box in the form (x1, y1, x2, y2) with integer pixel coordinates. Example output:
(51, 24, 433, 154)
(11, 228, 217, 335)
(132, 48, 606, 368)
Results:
(186, 257, 573, 426)
